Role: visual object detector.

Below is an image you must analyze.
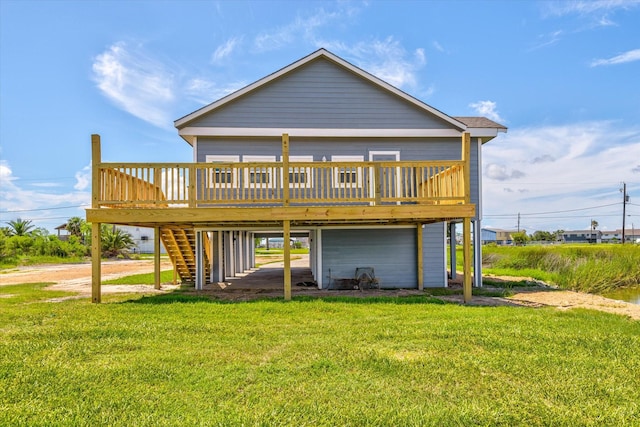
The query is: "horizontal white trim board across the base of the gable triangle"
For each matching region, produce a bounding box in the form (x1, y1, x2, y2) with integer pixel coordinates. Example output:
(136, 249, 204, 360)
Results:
(179, 127, 462, 138)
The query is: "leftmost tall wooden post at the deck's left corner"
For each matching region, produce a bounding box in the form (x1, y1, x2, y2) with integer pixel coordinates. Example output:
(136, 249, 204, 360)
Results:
(91, 134, 102, 303)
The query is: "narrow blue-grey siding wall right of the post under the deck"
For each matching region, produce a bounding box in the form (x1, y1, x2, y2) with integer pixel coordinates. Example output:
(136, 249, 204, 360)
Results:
(422, 222, 447, 288)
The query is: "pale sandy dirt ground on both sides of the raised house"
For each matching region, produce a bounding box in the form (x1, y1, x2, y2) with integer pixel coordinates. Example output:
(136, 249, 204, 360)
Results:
(0, 260, 640, 320)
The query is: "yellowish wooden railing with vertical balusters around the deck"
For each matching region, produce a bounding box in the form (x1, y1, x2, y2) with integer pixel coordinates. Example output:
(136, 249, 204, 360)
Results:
(94, 160, 468, 208)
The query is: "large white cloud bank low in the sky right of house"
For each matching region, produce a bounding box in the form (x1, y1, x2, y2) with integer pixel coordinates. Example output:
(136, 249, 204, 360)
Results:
(482, 122, 640, 232)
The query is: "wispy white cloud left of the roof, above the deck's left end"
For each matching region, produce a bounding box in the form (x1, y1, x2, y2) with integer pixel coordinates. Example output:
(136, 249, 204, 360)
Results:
(93, 42, 175, 127)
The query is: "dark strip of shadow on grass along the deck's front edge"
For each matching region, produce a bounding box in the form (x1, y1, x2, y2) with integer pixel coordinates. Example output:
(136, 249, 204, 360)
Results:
(120, 290, 450, 305)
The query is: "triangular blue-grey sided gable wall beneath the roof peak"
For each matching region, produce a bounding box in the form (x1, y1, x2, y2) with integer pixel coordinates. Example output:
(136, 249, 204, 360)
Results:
(188, 59, 451, 129)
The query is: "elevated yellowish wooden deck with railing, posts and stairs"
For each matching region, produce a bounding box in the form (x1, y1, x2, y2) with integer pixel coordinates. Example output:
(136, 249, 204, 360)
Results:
(87, 133, 475, 302)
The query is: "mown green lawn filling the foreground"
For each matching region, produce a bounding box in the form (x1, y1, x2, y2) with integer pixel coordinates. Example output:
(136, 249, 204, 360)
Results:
(0, 285, 640, 426)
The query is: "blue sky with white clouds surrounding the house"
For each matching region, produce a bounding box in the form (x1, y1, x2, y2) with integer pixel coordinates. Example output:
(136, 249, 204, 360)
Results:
(0, 0, 640, 233)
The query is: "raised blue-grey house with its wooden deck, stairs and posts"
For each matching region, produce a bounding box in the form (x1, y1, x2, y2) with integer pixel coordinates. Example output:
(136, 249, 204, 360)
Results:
(87, 49, 506, 302)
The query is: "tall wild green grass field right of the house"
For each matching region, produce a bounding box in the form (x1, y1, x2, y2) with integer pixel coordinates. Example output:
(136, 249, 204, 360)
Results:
(456, 244, 640, 293)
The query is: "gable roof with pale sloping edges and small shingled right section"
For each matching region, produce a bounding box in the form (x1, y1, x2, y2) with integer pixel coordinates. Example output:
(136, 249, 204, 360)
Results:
(174, 49, 506, 142)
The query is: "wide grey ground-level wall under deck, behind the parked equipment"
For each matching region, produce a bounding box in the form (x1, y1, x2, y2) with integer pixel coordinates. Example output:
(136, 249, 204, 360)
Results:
(321, 228, 418, 288)
